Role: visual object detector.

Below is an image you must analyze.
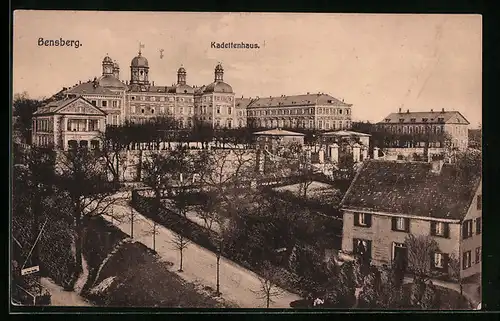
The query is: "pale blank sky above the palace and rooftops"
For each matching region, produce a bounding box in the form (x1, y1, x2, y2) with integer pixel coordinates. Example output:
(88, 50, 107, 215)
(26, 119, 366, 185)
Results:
(13, 11, 482, 127)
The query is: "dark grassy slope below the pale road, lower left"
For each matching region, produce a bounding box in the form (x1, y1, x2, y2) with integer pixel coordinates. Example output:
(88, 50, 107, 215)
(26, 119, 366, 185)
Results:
(81, 218, 232, 308)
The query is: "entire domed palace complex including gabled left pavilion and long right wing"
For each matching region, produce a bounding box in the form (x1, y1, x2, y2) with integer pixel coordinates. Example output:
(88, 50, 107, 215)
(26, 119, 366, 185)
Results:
(32, 50, 352, 149)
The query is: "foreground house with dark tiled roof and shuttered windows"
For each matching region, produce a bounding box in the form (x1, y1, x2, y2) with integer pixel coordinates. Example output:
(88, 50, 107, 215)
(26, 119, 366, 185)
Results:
(341, 160, 482, 279)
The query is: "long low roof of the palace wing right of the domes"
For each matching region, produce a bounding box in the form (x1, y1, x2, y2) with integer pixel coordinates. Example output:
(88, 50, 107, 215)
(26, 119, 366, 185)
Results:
(244, 94, 352, 108)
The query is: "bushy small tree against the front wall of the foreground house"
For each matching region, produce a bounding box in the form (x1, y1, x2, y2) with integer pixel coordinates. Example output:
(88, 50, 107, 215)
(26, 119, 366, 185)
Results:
(405, 234, 439, 283)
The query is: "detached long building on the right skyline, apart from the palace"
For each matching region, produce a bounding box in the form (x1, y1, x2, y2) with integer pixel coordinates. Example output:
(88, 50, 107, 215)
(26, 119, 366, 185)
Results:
(377, 108, 469, 150)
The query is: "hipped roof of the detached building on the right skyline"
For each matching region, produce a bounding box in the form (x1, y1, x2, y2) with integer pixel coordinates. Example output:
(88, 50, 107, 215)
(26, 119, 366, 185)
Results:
(380, 111, 469, 125)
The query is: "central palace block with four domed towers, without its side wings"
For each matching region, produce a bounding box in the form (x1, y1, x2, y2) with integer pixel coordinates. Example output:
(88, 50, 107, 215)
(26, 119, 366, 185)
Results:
(59, 51, 237, 128)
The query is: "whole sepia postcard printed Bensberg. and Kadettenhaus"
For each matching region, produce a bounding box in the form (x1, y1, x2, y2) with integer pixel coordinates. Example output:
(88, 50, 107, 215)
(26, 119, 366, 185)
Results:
(9, 10, 482, 311)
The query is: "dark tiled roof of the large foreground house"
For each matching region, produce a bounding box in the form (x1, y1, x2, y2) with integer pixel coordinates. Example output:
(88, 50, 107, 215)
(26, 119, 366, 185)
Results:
(341, 160, 481, 220)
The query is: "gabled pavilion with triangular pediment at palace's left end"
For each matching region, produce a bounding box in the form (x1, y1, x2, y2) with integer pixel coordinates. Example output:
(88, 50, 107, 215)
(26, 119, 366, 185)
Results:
(32, 96, 107, 150)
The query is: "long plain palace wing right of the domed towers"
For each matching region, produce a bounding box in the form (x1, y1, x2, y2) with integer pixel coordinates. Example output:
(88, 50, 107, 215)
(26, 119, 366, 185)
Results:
(246, 93, 352, 130)
